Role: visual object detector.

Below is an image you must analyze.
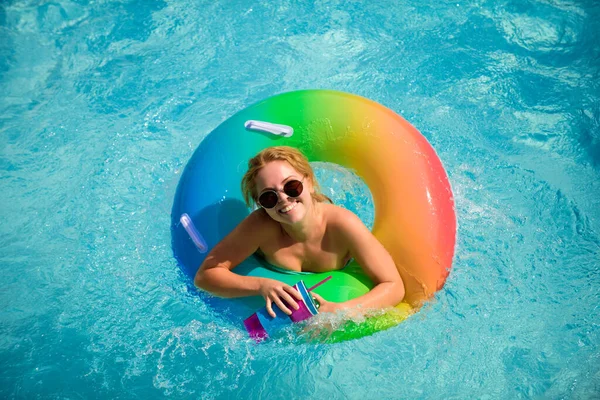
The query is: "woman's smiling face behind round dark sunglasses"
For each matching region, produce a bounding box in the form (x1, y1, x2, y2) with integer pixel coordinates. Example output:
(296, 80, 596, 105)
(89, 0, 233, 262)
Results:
(255, 161, 313, 224)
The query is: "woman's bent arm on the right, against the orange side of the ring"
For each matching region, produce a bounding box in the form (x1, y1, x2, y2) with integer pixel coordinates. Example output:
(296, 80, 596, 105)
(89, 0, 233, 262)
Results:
(315, 208, 404, 312)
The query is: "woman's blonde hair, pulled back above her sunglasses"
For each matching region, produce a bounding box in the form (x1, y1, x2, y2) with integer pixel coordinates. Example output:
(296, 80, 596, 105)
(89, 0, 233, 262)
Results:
(242, 146, 333, 207)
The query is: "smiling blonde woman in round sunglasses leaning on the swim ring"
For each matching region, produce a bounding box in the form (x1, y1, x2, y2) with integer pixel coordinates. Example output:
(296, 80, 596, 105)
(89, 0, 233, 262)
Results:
(194, 146, 404, 317)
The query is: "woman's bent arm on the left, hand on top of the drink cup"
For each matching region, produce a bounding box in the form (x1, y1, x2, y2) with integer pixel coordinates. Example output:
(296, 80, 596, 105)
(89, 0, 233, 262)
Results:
(194, 210, 302, 317)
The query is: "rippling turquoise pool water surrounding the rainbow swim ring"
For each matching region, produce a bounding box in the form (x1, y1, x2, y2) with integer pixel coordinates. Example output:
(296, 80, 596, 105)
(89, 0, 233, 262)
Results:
(0, 0, 600, 399)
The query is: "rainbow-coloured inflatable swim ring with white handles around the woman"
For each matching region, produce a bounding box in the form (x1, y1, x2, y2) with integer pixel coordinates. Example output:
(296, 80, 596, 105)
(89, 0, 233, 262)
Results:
(172, 90, 456, 338)
